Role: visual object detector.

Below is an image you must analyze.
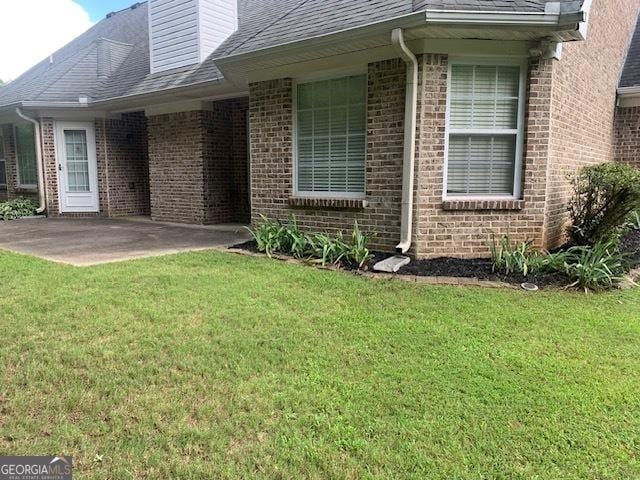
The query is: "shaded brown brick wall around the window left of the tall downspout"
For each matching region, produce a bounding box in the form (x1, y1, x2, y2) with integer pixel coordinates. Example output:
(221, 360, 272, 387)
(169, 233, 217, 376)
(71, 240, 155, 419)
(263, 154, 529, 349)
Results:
(249, 59, 405, 250)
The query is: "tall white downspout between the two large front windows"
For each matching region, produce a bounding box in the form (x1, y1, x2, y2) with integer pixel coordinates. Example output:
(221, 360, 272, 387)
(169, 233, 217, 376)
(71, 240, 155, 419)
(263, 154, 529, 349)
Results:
(391, 28, 418, 254)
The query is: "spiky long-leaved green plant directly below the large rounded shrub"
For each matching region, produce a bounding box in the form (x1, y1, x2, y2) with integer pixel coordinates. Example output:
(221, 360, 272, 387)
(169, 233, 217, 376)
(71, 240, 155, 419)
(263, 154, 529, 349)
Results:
(564, 242, 628, 291)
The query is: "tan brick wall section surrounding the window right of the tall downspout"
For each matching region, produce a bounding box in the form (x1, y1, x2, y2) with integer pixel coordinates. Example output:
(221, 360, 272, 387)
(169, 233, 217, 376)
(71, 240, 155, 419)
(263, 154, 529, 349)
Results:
(414, 55, 551, 257)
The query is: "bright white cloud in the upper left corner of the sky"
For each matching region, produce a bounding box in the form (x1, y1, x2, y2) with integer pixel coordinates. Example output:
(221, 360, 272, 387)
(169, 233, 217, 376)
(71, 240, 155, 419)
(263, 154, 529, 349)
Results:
(0, 0, 92, 82)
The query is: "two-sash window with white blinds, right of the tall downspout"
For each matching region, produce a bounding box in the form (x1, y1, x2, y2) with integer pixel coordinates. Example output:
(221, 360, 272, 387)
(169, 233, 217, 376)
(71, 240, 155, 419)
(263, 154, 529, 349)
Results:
(446, 65, 522, 197)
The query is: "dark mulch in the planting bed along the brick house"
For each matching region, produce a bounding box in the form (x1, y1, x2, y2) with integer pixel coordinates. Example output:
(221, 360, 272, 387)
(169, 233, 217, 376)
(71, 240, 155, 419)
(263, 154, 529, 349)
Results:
(233, 230, 640, 287)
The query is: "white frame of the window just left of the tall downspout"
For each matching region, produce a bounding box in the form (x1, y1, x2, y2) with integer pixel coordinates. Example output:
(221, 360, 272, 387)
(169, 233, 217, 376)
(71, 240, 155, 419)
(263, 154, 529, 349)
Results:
(292, 67, 369, 200)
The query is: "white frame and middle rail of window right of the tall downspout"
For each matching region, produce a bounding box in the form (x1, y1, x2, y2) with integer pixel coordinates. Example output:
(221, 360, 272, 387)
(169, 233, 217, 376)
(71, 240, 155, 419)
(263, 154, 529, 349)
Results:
(442, 57, 529, 201)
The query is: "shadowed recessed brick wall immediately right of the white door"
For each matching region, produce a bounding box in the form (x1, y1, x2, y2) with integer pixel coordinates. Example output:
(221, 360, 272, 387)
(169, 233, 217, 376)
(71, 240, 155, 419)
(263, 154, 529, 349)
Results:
(95, 112, 150, 216)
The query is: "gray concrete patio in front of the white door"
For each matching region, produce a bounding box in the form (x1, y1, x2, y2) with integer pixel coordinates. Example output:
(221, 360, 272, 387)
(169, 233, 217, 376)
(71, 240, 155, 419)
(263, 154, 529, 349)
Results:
(0, 217, 250, 266)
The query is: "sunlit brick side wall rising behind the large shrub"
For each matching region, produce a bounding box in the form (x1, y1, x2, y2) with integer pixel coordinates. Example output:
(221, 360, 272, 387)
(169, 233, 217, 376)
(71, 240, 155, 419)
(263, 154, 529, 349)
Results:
(545, 0, 640, 247)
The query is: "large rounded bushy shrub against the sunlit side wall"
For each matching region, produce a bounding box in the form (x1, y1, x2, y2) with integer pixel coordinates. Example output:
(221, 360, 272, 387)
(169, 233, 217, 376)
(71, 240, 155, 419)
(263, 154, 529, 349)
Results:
(568, 163, 640, 246)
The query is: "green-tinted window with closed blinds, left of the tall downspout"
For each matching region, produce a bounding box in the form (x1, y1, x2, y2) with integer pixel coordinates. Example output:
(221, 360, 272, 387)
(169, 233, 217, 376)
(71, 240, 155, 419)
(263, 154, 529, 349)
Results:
(296, 75, 367, 197)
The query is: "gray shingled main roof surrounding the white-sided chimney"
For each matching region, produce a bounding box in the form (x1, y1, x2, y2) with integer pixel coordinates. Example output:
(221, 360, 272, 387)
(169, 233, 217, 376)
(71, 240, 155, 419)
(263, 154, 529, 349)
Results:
(0, 0, 579, 106)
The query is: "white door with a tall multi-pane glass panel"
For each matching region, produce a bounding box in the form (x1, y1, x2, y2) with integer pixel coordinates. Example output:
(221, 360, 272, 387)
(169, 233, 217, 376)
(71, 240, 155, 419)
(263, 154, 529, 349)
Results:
(56, 122, 100, 213)
